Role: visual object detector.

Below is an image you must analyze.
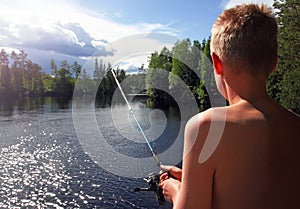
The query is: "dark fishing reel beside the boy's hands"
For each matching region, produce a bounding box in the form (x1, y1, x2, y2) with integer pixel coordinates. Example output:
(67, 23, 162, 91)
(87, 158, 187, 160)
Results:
(134, 173, 165, 205)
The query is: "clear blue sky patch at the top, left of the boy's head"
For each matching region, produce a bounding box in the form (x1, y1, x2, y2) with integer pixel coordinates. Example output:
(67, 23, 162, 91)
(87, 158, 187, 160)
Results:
(82, 0, 225, 39)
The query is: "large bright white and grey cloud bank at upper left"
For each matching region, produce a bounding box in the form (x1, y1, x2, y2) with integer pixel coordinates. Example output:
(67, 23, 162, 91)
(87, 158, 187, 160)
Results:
(0, 0, 176, 69)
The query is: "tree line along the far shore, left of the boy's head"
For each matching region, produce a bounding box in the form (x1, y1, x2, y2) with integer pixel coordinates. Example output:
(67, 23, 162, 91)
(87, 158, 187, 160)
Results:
(0, 39, 214, 109)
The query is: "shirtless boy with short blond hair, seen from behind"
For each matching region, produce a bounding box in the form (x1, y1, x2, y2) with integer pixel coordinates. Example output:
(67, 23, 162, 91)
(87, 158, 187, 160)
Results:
(161, 4, 300, 209)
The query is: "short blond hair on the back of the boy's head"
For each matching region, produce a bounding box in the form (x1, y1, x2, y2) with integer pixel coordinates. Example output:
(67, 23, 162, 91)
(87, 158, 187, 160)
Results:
(211, 4, 277, 74)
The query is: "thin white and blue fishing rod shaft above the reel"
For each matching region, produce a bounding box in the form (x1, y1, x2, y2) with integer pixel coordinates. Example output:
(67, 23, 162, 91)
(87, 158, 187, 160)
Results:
(111, 69, 161, 167)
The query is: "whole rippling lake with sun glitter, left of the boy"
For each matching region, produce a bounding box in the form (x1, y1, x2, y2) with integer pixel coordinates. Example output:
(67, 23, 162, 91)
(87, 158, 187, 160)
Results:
(0, 98, 188, 208)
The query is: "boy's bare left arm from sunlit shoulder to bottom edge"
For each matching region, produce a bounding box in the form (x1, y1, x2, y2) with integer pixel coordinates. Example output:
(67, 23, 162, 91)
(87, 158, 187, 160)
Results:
(173, 112, 215, 209)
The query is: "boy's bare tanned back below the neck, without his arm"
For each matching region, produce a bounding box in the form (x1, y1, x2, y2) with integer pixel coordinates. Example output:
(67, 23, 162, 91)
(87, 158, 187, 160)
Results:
(210, 101, 300, 209)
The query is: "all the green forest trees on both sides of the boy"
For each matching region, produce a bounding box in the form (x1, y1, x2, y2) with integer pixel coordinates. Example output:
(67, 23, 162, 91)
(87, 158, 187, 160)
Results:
(0, 0, 300, 113)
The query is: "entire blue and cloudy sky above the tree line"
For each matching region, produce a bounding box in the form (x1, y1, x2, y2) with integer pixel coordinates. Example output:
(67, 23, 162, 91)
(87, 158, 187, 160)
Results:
(0, 0, 273, 71)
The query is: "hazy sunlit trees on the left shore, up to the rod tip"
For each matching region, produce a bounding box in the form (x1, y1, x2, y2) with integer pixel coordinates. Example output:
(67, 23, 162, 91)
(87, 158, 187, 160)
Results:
(0, 49, 125, 98)
